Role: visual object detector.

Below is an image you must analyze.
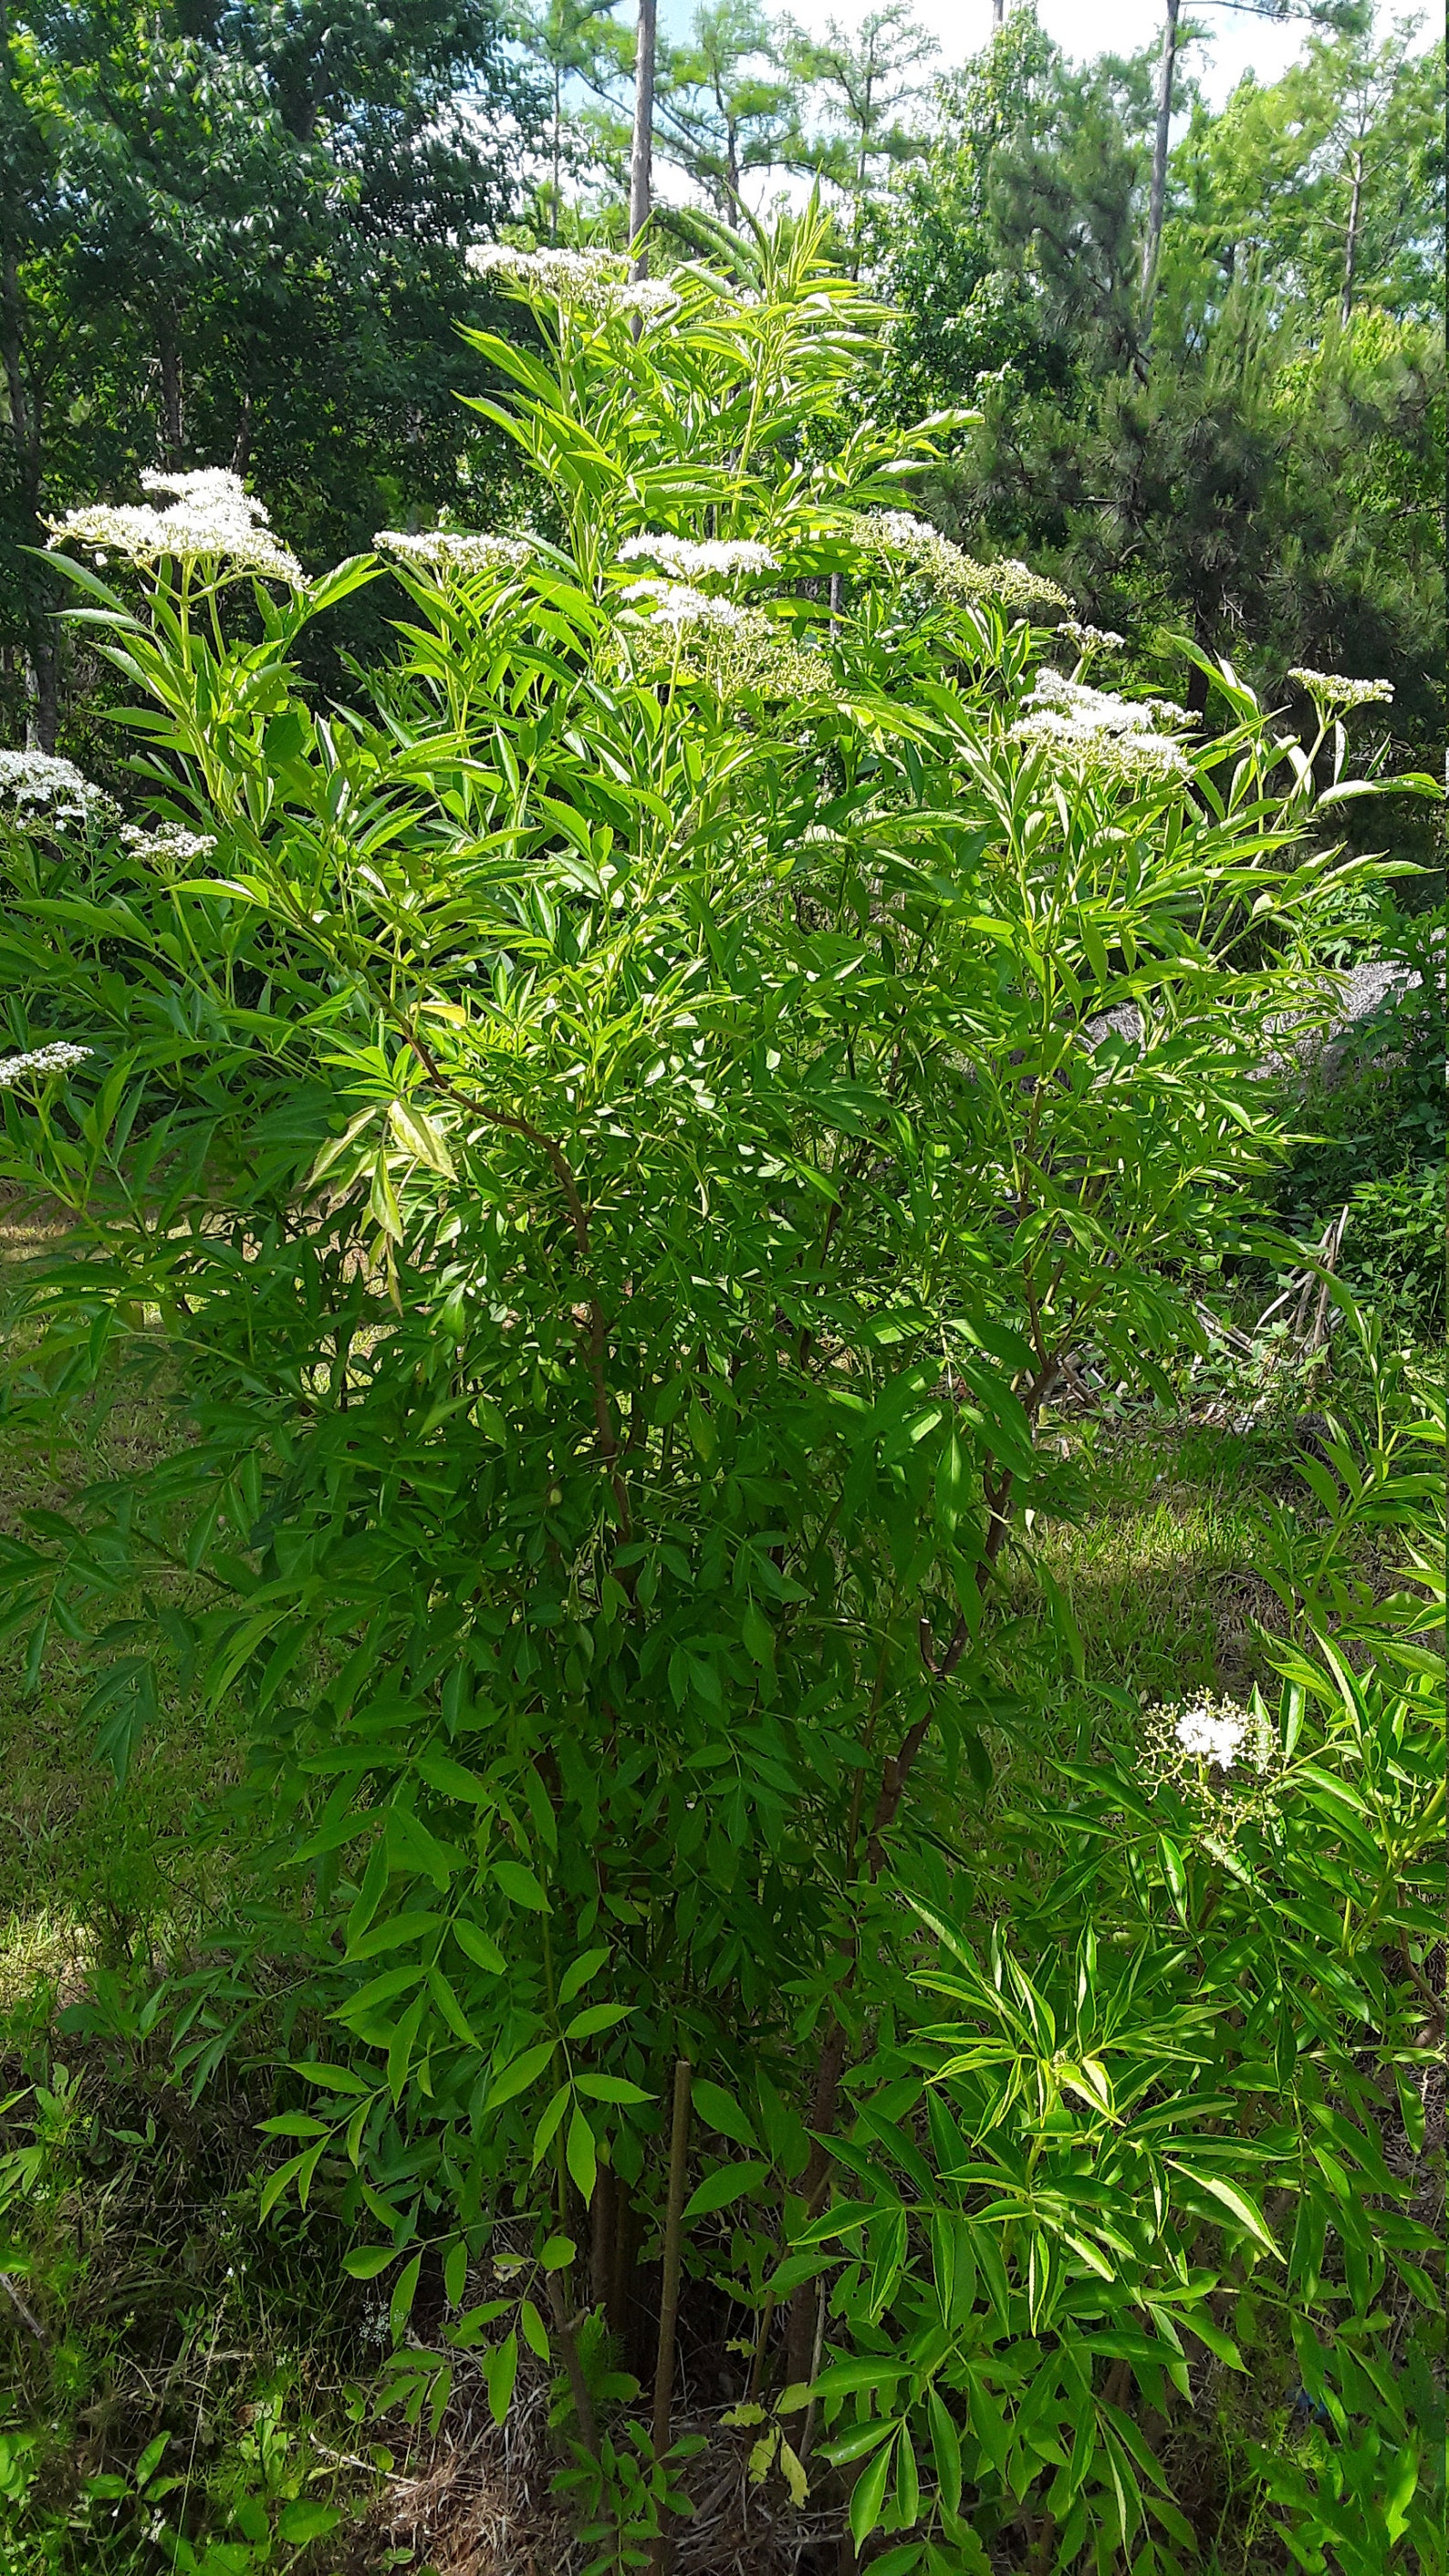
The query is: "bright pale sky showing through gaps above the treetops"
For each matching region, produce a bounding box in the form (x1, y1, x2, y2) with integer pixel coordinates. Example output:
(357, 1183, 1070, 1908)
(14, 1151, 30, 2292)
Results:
(660, 0, 1308, 106)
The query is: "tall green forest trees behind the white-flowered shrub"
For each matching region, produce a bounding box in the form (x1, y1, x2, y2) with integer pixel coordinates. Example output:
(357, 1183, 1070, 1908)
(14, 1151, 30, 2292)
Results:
(0, 0, 1444, 814)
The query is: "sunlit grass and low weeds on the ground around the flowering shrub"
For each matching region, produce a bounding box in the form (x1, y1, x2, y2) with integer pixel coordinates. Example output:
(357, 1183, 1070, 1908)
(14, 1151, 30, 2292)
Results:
(0, 1223, 1442, 2576)
